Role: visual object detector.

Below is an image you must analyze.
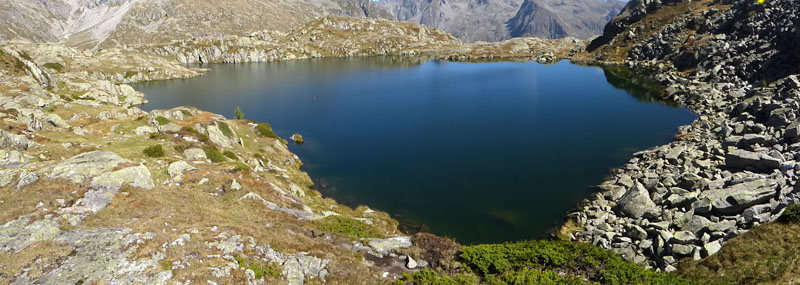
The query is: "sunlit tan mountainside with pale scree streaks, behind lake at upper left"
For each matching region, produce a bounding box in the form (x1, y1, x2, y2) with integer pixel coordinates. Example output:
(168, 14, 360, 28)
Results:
(0, 0, 389, 48)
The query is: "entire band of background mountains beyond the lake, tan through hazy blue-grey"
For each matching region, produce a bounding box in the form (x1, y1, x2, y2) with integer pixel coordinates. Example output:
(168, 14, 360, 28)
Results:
(0, 0, 623, 48)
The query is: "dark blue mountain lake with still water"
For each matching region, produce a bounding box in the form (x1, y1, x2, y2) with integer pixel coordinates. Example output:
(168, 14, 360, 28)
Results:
(134, 57, 695, 244)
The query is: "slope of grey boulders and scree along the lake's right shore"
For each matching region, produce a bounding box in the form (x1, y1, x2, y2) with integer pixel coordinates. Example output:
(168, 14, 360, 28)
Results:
(569, 1, 800, 271)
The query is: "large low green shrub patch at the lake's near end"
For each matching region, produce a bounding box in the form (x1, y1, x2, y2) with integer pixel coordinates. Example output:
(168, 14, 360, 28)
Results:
(459, 241, 689, 284)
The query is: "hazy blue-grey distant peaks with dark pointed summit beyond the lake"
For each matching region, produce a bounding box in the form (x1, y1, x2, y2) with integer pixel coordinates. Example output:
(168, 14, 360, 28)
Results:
(378, 0, 625, 42)
